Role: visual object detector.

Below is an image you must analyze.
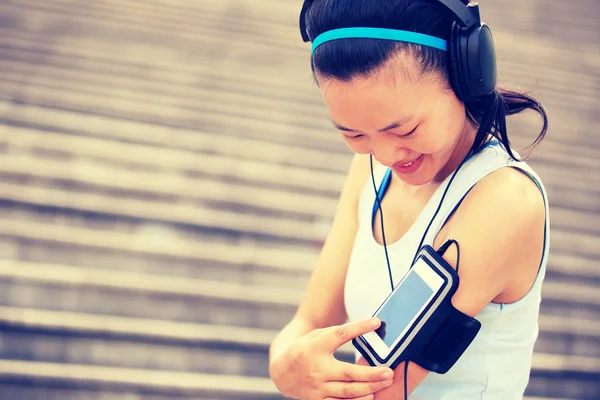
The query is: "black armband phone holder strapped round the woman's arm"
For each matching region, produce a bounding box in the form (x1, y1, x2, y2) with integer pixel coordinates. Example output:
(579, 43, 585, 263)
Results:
(352, 245, 481, 374)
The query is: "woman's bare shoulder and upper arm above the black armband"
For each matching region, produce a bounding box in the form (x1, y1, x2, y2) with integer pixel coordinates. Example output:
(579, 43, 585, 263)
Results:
(436, 168, 546, 315)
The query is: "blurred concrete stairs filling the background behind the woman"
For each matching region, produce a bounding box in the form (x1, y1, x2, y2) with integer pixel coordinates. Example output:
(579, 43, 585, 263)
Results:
(0, 0, 600, 400)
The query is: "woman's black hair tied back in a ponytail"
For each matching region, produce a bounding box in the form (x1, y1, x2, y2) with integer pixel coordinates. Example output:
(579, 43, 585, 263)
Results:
(306, 0, 548, 160)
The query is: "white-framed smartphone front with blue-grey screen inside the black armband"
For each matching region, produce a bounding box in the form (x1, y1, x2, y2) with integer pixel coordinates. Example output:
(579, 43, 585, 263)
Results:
(375, 259, 443, 348)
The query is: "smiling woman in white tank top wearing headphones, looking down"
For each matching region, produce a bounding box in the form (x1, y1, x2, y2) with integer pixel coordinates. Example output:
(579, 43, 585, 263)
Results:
(270, 0, 549, 400)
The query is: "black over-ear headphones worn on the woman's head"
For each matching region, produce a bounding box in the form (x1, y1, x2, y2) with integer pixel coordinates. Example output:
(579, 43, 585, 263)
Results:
(300, 0, 496, 102)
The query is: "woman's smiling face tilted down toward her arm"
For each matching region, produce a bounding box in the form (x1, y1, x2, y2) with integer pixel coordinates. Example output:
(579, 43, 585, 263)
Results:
(317, 55, 475, 186)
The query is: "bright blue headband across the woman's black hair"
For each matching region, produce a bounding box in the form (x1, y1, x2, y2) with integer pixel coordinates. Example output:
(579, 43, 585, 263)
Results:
(312, 28, 448, 53)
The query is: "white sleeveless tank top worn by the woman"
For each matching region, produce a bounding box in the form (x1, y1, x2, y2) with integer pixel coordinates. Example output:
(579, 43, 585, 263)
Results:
(344, 140, 550, 400)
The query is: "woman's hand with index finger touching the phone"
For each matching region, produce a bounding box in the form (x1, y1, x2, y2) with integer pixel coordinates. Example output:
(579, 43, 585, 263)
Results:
(270, 319, 394, 400)
